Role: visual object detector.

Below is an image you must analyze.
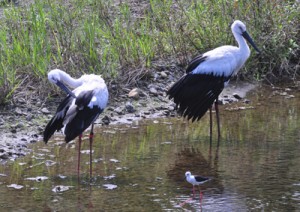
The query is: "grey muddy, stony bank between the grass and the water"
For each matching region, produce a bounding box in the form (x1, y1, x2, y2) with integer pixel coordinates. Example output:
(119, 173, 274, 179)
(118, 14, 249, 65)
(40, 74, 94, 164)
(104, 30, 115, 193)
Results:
(0, 72, 255, 161)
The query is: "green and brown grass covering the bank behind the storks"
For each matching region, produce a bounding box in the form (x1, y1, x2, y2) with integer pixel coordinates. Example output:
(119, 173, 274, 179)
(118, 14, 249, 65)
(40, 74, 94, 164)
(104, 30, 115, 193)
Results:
(0, 0, 300, 104)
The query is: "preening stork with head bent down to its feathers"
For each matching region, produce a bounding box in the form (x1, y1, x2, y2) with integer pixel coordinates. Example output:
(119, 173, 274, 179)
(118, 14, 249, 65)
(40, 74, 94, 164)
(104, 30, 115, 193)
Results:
(44, 69, 108, 177)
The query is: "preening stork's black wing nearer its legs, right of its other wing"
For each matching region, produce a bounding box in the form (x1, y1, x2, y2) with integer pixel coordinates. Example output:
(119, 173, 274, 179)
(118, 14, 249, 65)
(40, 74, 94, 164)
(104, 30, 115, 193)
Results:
(64, 90, 104, 142)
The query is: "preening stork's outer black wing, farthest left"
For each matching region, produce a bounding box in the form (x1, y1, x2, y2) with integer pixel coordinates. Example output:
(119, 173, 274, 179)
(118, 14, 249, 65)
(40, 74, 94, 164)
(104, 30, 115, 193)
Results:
(44, 95, 74, 143)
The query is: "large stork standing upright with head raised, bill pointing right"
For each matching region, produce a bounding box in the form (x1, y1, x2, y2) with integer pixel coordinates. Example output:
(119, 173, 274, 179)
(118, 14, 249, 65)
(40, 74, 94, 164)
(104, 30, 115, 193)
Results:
(167, 20, 260, 141)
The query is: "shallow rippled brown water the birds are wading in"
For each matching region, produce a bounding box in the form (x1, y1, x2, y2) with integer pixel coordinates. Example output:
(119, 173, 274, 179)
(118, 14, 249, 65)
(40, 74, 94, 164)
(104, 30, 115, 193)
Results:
(0, 85, 300, 211)
